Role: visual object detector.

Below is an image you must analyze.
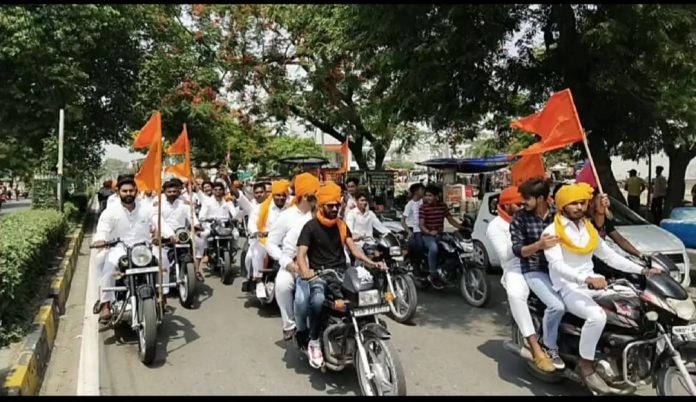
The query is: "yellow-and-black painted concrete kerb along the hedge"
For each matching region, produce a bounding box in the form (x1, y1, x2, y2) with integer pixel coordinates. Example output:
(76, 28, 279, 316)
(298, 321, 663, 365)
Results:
(3, 201, 89, 396)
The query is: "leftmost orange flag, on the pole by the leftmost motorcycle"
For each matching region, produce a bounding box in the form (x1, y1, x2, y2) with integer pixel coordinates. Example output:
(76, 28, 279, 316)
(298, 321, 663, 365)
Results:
(133, 112, 162, 195)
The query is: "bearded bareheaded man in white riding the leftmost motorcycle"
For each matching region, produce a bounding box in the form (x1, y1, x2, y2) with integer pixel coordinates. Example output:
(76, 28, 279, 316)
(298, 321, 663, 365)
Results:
(92, 175, 175, 320)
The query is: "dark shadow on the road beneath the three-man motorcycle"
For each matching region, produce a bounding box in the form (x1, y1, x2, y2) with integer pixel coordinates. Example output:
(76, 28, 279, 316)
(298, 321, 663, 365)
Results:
(477, 339, 591, 396)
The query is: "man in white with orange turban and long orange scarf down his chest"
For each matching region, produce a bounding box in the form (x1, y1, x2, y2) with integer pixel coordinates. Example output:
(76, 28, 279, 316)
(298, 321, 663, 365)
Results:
(247, 180, 290, 299)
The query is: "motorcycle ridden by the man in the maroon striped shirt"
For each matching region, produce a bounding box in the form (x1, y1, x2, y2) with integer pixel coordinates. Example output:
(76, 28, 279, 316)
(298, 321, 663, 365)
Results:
(416, 230, 491, 307)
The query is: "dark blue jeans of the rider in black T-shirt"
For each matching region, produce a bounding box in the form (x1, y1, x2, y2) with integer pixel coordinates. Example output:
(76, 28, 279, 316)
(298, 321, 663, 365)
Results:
(295, 278, 326, 340)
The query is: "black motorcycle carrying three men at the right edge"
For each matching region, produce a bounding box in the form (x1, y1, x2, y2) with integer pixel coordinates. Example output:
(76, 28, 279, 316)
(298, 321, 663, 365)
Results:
(504, 254, 696, 396)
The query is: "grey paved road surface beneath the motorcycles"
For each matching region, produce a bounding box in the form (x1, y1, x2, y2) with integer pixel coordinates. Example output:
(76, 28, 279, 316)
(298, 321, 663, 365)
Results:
(41, 225, 651, 395)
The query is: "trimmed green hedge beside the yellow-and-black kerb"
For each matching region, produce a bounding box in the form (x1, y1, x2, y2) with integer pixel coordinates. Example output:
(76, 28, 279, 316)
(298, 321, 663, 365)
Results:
(0, 210, 67, 347)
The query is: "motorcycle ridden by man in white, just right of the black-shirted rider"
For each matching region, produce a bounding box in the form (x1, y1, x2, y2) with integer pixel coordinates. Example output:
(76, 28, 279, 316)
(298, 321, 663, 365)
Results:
(363, 233, 418, 323)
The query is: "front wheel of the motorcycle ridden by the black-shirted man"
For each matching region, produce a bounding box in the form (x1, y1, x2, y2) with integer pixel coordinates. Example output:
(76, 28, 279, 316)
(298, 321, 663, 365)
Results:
(353, 334, 406, 396)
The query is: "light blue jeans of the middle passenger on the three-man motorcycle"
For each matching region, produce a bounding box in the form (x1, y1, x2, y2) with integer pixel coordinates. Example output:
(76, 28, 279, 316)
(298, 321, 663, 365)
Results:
(524, 272, 565, 349)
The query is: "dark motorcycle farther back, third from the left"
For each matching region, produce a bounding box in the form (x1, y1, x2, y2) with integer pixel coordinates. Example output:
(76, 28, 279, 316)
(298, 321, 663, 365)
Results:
(202, 219, 237, 285)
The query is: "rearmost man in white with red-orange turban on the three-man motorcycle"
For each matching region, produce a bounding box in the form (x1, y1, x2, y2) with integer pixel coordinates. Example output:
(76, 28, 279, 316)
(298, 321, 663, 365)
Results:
(486, 186, 556, 372)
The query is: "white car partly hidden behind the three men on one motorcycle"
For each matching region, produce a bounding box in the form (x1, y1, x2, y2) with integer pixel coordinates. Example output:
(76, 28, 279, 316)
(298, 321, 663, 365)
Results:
(472, 192, 691, 288)
